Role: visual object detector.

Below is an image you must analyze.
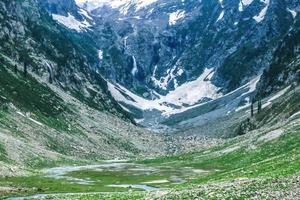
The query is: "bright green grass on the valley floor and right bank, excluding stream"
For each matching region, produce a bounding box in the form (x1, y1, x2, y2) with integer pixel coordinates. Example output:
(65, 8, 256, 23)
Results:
(0, 126, 300, 199)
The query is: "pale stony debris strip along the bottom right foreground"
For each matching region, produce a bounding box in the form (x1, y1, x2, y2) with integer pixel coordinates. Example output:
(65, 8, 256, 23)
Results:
(146, 175, 300, 200)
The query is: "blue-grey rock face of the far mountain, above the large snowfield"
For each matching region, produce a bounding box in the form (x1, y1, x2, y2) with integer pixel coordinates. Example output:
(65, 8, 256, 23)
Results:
(84, 0, 299, 97)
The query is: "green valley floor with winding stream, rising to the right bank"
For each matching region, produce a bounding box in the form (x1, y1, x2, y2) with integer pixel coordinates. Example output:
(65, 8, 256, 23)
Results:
(0, 117, 300, 200)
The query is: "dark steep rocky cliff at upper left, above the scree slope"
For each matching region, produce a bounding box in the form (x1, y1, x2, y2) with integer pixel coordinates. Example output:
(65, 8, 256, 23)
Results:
(0, 0, 129, 119)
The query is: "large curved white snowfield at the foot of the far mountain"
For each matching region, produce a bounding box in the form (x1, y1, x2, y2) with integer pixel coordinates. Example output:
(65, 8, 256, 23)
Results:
(108, 68, 261, 117)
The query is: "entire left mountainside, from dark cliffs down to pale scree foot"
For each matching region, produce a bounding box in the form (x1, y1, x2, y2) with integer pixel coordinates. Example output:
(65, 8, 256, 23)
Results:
(0, 0, 173, 170)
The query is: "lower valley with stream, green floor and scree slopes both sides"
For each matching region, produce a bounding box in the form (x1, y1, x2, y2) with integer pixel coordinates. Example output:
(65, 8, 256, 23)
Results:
(0, 62, 300, 200)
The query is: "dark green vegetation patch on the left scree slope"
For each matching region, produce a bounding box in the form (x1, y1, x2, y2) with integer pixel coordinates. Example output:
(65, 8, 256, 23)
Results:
(0, 63, 75, 135)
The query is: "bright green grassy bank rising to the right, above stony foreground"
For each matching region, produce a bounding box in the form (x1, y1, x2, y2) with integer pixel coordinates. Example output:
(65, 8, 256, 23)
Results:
(143, 126, 300, 183)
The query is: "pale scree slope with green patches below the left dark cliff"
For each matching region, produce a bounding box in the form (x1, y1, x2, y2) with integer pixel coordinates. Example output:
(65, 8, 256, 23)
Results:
(0, 54, 165, 173)
